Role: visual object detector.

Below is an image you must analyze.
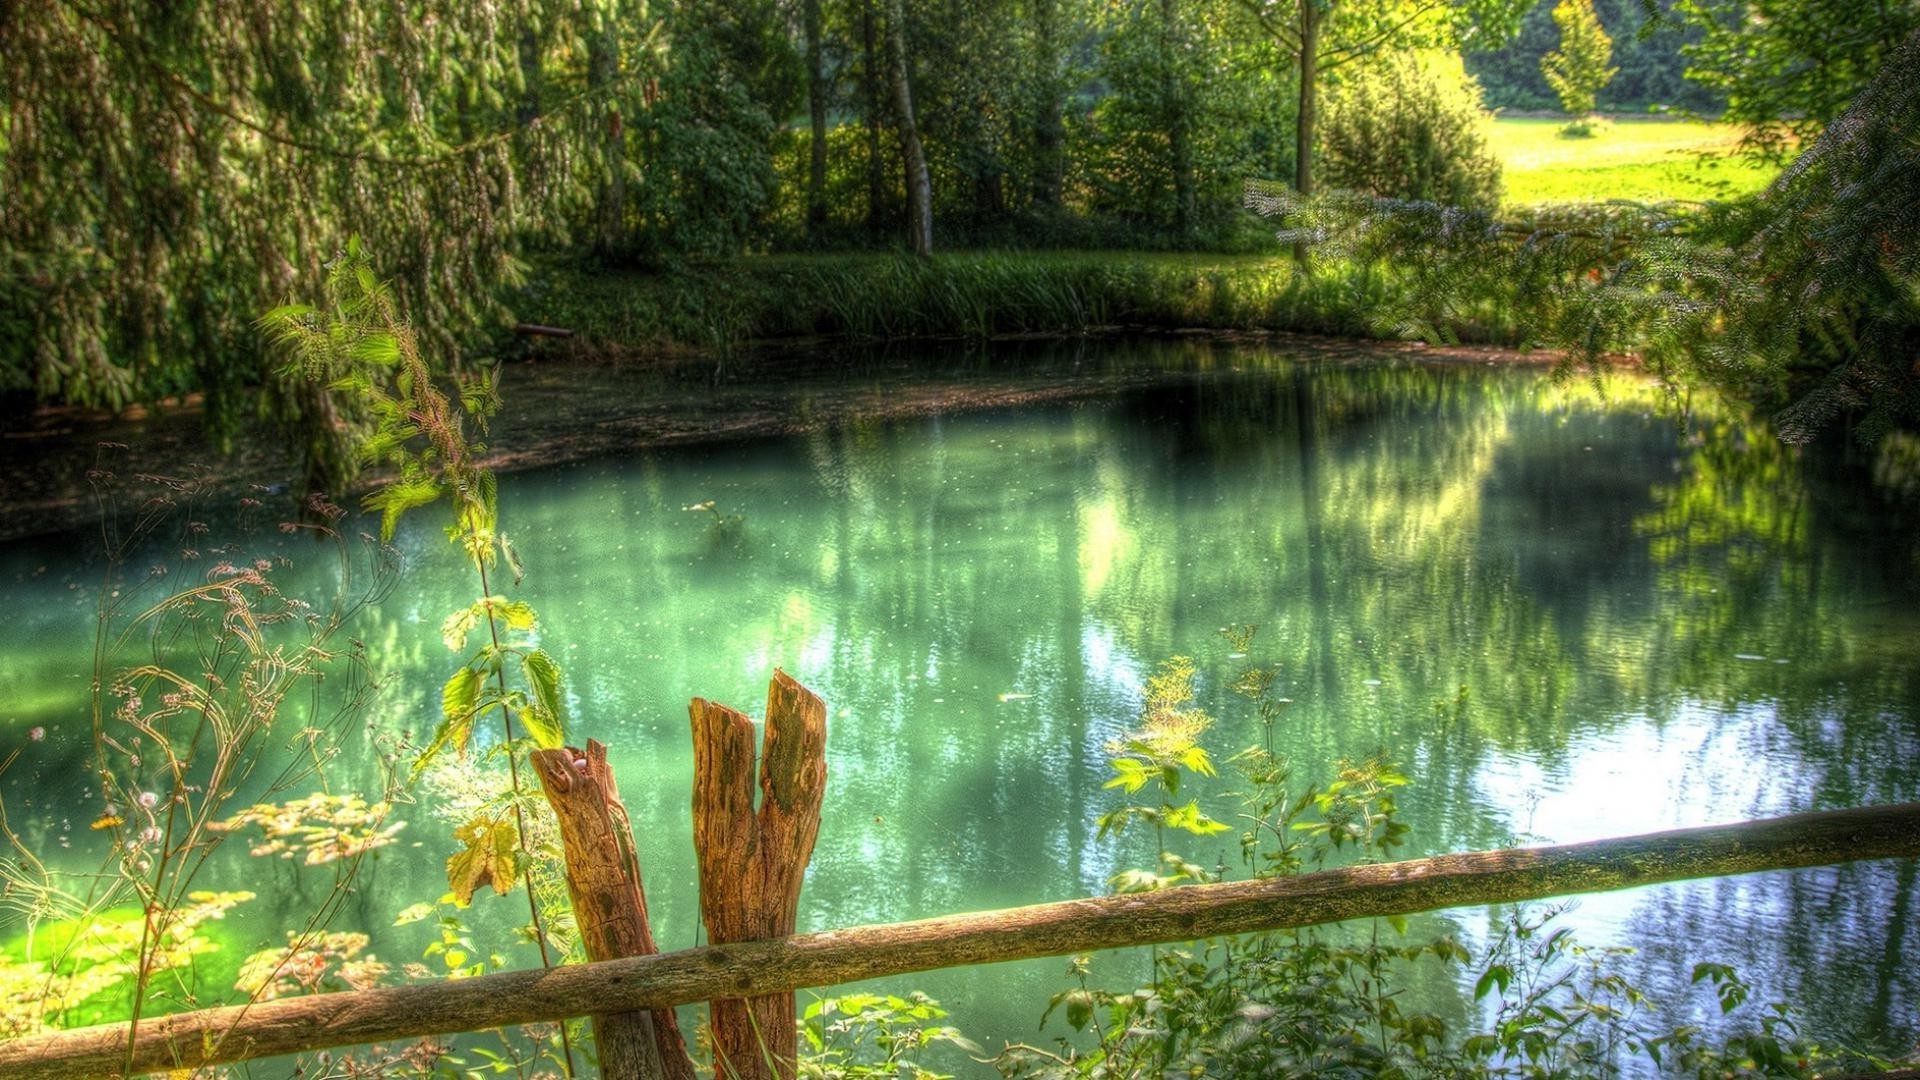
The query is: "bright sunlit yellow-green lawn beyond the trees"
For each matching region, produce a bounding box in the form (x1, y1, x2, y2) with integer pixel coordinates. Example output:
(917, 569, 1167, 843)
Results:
(1492, 119, 1778, 206)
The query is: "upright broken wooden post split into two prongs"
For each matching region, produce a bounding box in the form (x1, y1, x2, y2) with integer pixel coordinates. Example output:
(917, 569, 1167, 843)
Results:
(689, 669, 828, 1080)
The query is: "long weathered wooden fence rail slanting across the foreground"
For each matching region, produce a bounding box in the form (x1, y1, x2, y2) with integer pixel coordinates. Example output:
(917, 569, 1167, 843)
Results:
(0, 803, 1920, 1080)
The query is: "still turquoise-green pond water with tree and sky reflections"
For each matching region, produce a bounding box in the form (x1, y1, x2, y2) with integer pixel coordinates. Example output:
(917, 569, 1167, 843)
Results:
(0, 344, 1920, 1065)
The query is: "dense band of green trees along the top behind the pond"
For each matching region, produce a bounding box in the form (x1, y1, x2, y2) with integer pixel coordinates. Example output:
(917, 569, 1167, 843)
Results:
(0, 0, 1920, 463)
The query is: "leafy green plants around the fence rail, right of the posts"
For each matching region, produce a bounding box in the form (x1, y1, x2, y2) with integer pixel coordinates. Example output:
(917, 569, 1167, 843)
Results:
(995, 638, 1912, 1080)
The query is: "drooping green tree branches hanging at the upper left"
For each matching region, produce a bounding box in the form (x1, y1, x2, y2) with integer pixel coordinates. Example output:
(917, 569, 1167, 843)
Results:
(0, 0, 659, 470)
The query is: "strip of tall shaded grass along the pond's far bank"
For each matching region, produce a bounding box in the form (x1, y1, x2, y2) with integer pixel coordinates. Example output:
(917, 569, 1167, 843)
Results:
(515, 252, 1511, 352)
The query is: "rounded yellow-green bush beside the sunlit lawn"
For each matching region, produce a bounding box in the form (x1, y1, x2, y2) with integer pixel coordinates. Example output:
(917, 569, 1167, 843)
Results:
(1319, 52, 1500, 209)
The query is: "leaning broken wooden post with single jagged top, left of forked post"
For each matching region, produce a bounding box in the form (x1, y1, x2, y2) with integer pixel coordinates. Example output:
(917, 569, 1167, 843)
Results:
(534, 740, 693, 1080)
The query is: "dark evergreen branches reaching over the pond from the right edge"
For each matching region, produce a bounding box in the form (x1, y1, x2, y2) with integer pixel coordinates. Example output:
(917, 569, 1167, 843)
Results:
(1254, 31, 1920, 442)
